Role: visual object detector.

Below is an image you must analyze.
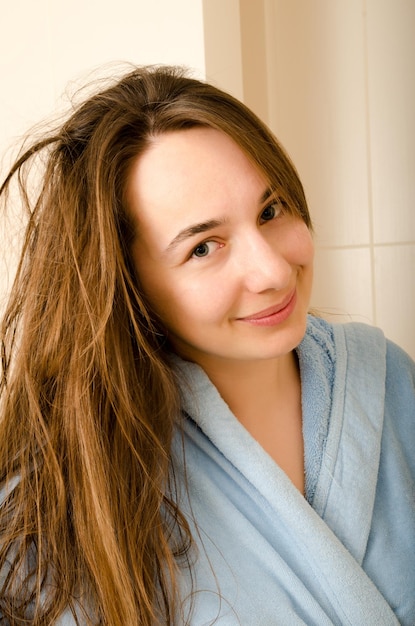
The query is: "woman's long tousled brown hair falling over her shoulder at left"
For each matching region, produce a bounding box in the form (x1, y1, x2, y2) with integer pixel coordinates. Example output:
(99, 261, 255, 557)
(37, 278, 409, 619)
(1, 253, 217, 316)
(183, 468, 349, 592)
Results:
(0, 67, 310, 626)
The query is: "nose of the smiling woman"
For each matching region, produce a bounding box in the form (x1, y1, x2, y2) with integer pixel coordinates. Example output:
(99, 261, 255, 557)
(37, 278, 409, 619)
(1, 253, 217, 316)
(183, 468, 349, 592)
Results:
(237, 231, 293, 293)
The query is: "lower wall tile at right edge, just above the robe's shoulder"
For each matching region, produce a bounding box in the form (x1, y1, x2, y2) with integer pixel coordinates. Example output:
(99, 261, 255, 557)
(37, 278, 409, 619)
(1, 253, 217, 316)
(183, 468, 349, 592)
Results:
(374, 243, 415, 359)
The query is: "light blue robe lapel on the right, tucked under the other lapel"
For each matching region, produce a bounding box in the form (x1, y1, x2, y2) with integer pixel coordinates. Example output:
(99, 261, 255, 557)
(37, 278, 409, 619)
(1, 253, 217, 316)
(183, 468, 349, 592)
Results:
(298, 318, 386, 564)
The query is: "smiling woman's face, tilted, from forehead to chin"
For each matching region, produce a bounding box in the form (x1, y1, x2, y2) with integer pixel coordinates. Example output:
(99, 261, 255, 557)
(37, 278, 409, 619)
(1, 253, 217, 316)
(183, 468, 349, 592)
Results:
(127, 128, 313, 367)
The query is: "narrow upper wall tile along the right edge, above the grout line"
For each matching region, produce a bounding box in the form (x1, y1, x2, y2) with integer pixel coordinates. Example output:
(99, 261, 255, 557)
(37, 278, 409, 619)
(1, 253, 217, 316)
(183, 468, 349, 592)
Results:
(367, 0, 415, 243)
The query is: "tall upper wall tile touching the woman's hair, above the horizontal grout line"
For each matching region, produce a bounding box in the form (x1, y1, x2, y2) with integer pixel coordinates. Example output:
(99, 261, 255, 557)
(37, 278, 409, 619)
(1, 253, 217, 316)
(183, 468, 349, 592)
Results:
(267, 0, 370, 246)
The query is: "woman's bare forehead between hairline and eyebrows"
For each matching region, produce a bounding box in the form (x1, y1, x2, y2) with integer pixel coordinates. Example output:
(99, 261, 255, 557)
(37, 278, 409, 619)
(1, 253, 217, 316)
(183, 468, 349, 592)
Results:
(126, 127, 264, 218)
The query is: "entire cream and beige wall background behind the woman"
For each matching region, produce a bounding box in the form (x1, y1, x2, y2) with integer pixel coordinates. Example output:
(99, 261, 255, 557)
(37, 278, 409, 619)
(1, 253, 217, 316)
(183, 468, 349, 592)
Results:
(0, 0, 415, 357)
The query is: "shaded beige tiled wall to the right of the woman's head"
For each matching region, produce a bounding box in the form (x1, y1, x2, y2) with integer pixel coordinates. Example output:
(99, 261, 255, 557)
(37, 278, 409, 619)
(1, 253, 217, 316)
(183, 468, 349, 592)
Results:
(204, 0, 415, 357)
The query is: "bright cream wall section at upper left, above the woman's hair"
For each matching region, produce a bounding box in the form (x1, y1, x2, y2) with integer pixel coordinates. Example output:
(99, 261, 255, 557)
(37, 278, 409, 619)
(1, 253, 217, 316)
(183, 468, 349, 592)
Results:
(0, 0, 205, 154)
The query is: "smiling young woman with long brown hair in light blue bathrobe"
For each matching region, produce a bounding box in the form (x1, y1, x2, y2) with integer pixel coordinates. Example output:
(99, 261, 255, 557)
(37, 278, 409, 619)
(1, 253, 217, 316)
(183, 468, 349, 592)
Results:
(0, 68, 415, 626)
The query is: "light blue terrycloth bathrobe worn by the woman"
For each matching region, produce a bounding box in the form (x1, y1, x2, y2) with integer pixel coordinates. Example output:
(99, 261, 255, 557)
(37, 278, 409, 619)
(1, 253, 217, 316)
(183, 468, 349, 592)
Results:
(175, 317, 415, 626)
